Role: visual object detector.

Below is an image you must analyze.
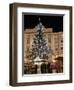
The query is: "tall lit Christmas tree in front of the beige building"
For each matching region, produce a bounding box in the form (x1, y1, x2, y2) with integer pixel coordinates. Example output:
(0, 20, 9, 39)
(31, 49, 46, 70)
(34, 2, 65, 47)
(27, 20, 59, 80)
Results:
(31, 18, 49, 59)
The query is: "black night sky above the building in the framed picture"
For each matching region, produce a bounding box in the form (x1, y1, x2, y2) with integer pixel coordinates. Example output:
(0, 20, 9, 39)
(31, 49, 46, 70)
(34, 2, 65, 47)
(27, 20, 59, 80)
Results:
(24, 15, 63, 32)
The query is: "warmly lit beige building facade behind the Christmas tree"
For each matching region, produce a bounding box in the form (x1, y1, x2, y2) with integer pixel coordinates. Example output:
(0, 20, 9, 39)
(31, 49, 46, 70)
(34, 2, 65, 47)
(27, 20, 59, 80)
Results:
(24, 28, 63, 63)
